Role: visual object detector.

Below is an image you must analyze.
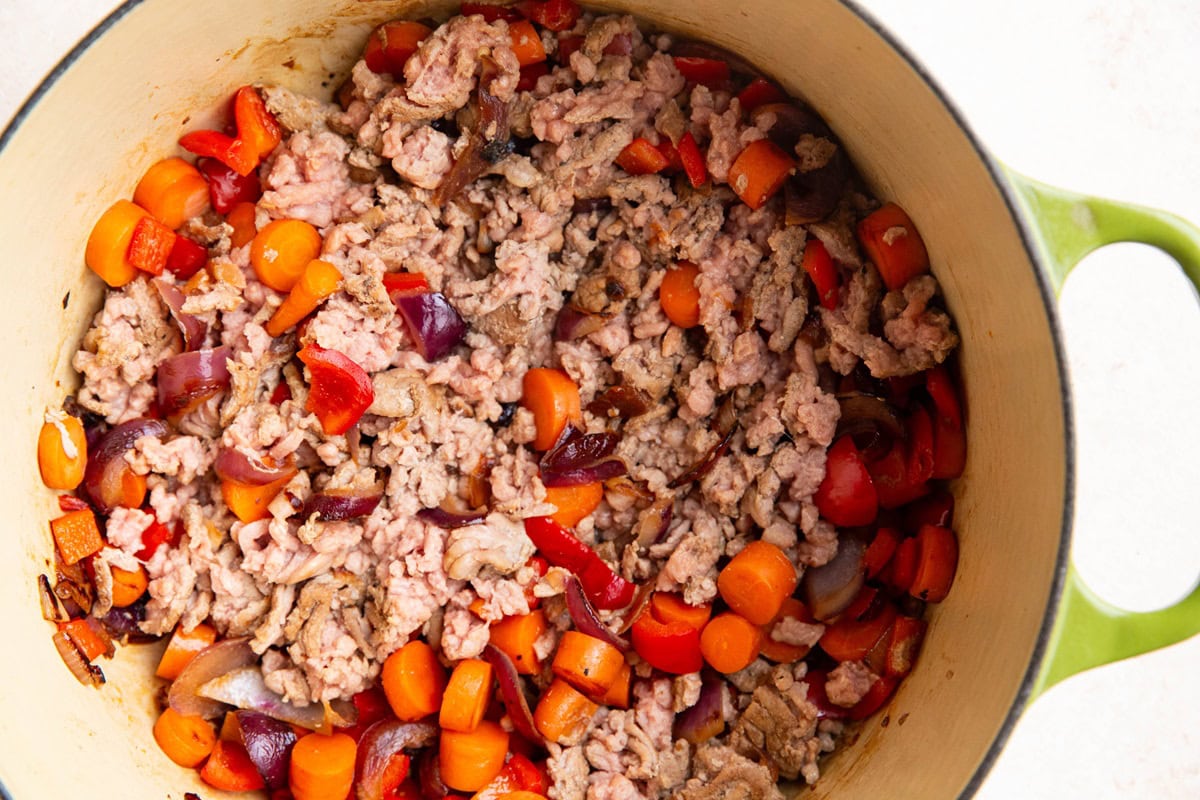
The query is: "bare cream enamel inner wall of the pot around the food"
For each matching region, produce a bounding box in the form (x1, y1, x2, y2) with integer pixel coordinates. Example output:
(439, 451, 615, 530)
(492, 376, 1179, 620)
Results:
(0, 0, 1068, 800)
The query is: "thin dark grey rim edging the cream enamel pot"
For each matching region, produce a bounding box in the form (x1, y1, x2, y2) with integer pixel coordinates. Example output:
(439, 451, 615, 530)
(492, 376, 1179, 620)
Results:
(0, 0, 1075, 800)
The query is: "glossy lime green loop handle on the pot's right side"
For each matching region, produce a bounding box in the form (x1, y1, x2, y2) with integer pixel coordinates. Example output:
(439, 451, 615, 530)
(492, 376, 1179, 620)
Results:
(1006, 170, 1200, 697)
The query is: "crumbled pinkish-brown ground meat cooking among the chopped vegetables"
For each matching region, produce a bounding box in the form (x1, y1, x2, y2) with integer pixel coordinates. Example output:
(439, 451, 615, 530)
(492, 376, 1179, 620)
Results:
(74, 9, 958, 800)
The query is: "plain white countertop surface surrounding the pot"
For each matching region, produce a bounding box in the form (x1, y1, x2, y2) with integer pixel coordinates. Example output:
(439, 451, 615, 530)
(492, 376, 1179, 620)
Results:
(0, 0, 1200, 800)
